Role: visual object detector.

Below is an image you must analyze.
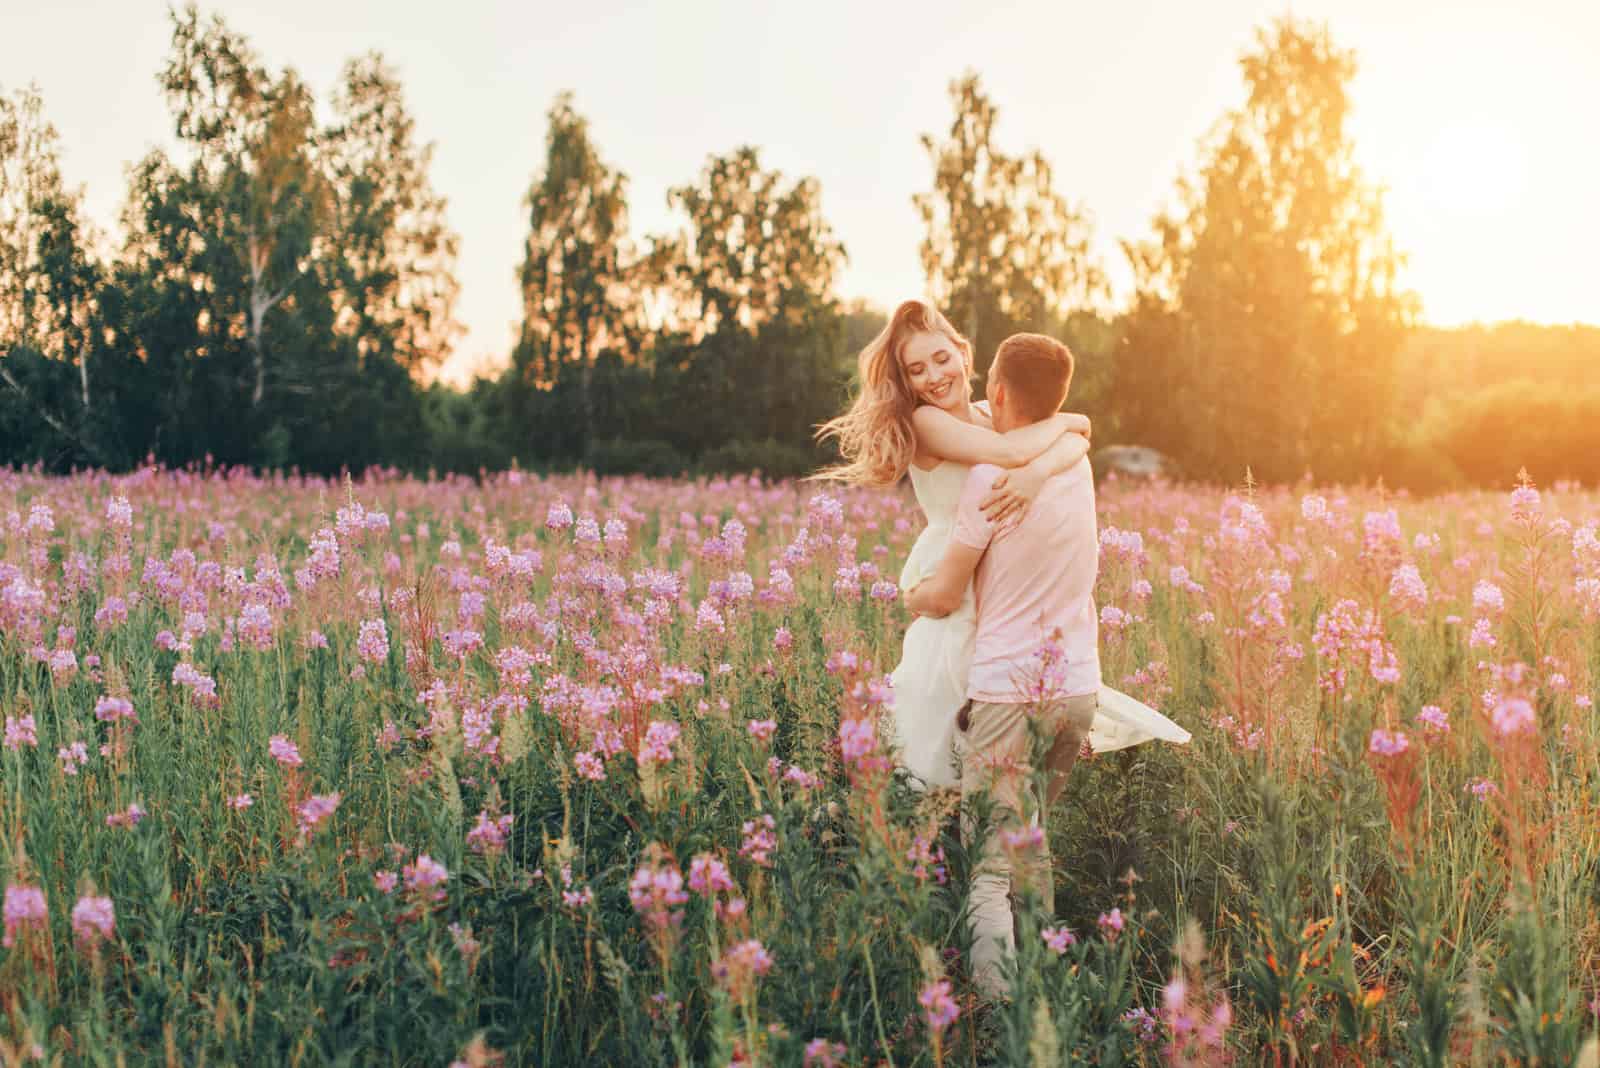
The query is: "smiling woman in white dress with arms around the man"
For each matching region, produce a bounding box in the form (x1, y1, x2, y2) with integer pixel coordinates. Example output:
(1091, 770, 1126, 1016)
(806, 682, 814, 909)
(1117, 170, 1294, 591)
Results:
(818, 301, 1189, 787)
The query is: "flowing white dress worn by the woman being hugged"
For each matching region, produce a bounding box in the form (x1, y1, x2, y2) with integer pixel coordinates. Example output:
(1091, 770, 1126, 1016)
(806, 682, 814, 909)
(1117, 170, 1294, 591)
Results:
(890, 460, 1189, 787)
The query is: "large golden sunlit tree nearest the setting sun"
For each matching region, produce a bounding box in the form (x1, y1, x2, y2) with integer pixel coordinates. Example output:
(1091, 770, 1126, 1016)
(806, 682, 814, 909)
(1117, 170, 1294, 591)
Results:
(1117, 19, 1414, 480)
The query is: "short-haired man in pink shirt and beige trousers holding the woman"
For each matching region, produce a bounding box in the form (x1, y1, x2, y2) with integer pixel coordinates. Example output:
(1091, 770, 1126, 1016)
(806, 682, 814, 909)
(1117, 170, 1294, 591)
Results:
(906, 334, 1101, 996)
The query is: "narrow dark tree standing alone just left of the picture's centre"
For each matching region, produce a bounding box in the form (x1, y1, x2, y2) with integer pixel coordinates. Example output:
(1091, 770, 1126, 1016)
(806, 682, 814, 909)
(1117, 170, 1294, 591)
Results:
(512, 93, 637, 452)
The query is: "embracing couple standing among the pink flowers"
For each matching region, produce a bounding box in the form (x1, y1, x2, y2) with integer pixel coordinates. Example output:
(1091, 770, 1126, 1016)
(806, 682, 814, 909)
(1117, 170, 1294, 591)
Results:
(822, 301, 1189, 996)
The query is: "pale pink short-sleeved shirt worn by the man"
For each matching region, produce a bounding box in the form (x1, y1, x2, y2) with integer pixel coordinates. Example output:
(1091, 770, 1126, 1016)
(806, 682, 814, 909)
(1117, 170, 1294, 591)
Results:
(952, 462, 1101, 703)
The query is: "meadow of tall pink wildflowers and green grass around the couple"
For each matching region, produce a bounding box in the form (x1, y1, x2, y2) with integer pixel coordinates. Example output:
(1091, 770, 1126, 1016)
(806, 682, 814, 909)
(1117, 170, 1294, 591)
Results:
(0, 470, 1600, 1066)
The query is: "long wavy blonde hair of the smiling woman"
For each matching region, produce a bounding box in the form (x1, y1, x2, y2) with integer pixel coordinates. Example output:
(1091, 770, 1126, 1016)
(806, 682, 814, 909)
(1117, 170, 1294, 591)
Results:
(811, 301, 973, 486)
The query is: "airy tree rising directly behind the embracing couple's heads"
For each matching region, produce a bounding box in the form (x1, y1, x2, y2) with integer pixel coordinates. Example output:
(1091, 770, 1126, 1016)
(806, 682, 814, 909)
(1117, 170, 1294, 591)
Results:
(912, 74, 1106, 373)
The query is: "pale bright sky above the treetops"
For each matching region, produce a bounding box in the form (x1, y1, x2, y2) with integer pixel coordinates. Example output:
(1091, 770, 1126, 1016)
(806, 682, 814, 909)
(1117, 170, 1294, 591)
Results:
(0, 0, 1600, 382)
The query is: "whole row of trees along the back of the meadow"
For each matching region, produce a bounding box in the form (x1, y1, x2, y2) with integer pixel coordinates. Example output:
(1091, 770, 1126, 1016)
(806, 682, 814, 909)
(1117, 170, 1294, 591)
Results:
(0, 6, 1600, 489)
